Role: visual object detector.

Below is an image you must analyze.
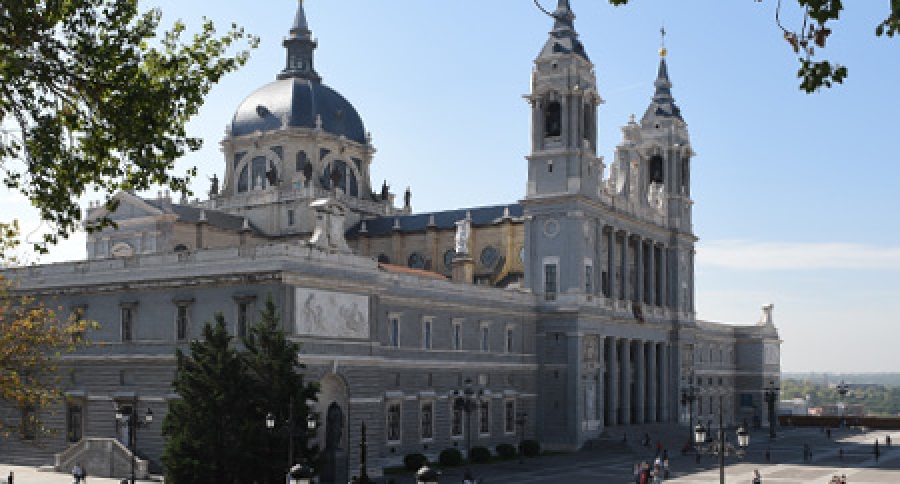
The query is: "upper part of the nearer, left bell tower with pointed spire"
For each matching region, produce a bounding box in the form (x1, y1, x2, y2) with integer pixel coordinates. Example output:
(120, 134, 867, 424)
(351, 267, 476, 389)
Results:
(525, 0, 603, 198)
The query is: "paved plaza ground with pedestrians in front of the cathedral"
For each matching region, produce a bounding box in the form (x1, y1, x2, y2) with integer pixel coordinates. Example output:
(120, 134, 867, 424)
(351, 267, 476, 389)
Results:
(0, 429, 900, 484)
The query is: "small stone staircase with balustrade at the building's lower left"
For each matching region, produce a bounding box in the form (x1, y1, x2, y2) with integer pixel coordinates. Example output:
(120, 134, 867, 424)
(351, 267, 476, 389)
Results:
(53, 437, 149, 479)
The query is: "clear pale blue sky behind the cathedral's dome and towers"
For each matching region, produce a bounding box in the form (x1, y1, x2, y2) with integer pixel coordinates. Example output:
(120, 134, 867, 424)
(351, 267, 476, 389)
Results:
(4, 0, 900, 371)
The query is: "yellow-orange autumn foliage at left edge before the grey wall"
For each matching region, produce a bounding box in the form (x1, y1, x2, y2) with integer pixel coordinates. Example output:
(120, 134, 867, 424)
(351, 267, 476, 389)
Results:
(0, 224, 97, 436)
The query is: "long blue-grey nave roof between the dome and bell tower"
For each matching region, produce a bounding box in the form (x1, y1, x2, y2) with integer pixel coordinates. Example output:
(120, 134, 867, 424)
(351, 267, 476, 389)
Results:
(347, 203, 525, 237)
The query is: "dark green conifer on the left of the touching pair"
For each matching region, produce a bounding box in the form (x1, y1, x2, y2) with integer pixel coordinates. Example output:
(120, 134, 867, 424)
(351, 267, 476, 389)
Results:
(162, 313, 264, 484)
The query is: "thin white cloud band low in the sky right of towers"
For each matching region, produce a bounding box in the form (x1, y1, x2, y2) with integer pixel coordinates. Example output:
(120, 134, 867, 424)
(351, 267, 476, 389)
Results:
(697, 240, 900, 271)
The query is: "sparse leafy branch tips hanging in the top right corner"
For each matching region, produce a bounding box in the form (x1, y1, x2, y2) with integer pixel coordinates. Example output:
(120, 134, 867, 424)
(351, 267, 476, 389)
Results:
(604, 0, 900, 93)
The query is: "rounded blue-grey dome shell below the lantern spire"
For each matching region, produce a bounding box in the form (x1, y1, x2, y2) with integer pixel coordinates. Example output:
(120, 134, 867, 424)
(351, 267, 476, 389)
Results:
(231, 77, 366, 144)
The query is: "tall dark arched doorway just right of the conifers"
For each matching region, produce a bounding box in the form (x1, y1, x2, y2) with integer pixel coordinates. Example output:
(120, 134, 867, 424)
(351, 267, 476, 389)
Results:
(316, 374, 348, 484)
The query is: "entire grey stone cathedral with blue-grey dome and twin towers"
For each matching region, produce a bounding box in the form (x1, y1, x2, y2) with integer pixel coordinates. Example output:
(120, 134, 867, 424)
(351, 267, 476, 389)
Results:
(0, 0, 780, 482)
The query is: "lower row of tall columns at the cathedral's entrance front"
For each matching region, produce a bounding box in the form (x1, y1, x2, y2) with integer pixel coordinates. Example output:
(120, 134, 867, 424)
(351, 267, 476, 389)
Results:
(603, 336, 676, 426)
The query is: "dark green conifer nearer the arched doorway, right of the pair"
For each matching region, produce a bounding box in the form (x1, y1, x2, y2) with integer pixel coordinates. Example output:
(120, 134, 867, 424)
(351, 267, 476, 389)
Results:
(243, 295, 319, 483)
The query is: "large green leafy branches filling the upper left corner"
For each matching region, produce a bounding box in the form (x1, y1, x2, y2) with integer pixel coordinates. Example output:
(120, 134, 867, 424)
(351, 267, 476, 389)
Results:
(0, 0, 257, 250)
